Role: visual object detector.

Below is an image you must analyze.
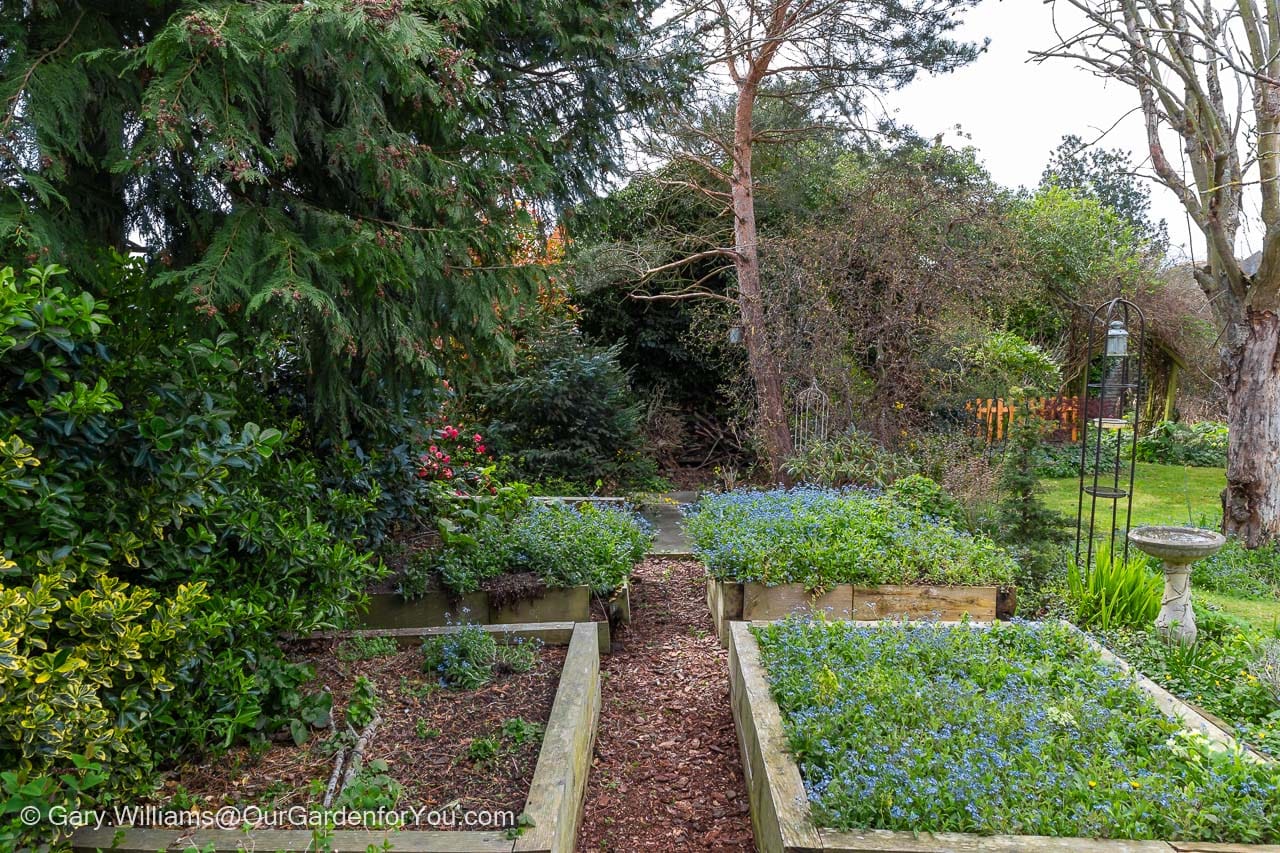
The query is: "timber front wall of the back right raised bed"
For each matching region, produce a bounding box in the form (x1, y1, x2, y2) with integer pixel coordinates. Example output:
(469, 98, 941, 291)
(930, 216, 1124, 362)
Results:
(707, 575, 1016, 646)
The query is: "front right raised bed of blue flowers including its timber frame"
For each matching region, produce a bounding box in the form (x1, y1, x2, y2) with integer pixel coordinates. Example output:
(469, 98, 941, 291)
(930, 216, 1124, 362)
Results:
(730, 620, 1280, 853)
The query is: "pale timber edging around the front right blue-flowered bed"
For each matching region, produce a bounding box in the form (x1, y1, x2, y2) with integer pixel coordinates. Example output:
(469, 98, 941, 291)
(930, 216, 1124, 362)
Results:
(727, 620, 1280, 853)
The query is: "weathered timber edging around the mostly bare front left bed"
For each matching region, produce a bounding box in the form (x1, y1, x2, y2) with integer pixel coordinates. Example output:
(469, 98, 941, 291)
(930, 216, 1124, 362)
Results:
(72, 622, 600, 853)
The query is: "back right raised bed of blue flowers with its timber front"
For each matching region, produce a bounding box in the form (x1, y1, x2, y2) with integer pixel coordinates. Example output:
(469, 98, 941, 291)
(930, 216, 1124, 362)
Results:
(686, 478, 1016, 643)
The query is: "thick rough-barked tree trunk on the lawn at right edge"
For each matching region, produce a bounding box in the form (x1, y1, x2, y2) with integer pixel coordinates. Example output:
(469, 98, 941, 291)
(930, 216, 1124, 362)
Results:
(1222, 307, 1280, 548)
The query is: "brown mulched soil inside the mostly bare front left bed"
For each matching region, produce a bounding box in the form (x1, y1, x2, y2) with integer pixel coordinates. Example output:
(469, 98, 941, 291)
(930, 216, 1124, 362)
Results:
(159, 642, 564, 829)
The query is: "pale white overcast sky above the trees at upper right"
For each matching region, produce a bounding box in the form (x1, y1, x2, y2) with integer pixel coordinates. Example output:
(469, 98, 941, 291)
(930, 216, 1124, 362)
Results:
(884, 0, 1203, 263)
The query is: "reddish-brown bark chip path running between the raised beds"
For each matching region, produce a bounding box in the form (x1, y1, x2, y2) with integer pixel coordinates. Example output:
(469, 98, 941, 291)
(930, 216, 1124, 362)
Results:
(577, 557, 755, 853)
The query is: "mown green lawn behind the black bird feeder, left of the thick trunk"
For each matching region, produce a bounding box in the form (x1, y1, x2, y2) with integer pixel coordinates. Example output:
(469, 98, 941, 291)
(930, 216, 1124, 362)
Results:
(1043, 462, 1226, 528)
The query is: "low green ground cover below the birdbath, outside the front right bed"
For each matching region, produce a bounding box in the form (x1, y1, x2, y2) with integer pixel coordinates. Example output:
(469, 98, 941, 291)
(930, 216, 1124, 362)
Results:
(1100, 606, 1280, 758)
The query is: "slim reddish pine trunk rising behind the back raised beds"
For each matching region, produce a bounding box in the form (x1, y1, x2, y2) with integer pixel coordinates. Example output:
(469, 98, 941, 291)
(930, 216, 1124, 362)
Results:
(731, 82, 792, 482)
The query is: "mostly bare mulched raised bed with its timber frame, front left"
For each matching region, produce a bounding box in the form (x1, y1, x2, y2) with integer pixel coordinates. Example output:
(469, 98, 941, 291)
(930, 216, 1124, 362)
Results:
(72, 624, 600, 853)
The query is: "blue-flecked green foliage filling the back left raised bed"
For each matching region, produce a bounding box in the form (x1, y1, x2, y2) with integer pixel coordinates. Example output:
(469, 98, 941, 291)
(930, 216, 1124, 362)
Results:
(434, 502, 653, 596)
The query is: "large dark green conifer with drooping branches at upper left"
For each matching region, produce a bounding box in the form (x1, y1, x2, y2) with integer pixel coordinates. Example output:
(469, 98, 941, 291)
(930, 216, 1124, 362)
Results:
(0, 0, 673, 432)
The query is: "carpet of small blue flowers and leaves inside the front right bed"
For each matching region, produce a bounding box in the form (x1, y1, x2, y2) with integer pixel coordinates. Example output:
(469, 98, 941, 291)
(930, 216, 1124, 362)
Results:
(753, 620, 1280, 843)
